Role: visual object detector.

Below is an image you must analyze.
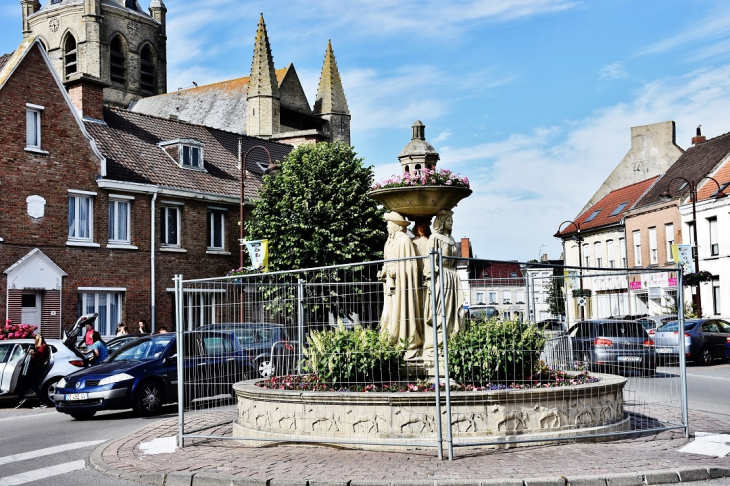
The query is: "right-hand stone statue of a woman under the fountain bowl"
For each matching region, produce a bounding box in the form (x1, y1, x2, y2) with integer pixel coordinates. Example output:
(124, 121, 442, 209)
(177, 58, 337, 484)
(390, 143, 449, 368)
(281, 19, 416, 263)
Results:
(423, 209, 464, 356)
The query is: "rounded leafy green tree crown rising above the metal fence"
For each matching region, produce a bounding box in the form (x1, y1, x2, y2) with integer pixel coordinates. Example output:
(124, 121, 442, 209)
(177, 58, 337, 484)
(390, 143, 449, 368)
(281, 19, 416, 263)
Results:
(246, 142, 387, 271)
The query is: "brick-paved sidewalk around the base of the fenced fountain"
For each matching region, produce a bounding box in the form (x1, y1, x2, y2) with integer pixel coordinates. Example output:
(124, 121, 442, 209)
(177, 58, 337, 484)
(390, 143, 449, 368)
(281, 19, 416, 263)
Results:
(91, 413, 730, 486)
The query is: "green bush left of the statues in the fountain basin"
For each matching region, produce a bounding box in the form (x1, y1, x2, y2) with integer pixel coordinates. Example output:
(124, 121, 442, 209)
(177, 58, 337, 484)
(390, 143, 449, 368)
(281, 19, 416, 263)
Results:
(304, 326, 405, 384)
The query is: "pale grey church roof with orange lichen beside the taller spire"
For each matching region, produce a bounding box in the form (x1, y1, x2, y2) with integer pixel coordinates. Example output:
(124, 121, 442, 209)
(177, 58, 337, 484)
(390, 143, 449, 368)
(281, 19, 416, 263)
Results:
(130, 68, 288, 133)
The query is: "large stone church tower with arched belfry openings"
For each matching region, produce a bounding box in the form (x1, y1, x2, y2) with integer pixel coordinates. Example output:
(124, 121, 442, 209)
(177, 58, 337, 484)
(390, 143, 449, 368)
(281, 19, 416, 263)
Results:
(21, 0, 167, 108)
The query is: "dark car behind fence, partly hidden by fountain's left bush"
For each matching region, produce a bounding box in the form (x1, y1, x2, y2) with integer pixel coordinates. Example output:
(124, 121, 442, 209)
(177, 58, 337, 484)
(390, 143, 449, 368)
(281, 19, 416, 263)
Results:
(201, 322, 299, 378)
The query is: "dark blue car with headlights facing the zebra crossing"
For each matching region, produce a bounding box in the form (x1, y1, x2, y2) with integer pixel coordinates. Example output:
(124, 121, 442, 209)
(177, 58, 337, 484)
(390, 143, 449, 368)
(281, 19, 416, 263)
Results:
(53, 331, 254, 420)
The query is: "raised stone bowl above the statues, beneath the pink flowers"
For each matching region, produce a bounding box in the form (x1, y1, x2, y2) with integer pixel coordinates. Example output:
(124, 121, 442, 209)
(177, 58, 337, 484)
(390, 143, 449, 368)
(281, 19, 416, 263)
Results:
(368, 186, 472, 218)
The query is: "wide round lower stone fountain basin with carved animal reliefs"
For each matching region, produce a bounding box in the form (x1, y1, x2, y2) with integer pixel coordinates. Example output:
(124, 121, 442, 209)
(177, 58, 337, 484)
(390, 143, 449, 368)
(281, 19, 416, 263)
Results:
(233, 373, 629, 450)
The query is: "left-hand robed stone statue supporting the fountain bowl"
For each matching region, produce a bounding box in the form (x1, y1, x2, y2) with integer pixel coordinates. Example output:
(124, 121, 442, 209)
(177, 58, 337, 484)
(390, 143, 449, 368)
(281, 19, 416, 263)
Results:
(378, 211, 423, 358)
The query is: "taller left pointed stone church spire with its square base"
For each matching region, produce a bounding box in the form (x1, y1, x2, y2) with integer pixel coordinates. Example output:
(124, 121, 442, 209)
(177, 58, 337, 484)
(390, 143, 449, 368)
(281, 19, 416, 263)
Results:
(246, 14, 281, 137)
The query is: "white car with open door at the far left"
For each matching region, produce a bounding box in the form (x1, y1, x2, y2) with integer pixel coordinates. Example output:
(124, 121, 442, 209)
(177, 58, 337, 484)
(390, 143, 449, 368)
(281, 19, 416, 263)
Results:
(0, 339, 86, 405)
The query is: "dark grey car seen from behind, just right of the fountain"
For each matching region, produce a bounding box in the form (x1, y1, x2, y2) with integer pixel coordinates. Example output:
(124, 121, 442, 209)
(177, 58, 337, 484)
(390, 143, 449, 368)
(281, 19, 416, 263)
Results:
(568, 319, 656, 375)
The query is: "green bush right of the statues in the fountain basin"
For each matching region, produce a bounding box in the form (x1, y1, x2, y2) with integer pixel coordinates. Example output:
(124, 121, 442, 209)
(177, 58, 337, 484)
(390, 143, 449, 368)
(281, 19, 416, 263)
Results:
(449, 318, 545, 384)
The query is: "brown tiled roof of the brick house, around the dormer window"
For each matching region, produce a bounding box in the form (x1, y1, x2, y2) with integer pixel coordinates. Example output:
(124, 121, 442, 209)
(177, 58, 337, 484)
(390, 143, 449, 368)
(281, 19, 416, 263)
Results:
(85, 108, 293, 198)
